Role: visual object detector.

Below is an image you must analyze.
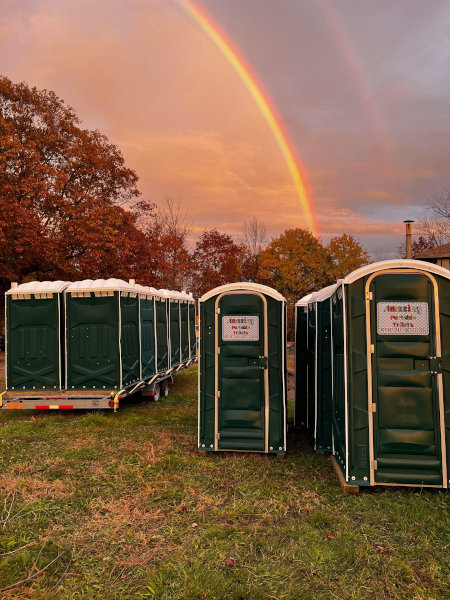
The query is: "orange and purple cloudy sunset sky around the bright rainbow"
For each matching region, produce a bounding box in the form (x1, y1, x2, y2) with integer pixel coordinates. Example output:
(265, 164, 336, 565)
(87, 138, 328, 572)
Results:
(0, 0, 450, 259)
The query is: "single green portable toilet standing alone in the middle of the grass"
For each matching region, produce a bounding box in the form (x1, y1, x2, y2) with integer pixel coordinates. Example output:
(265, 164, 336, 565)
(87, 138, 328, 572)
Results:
(198, 283, 286, 454)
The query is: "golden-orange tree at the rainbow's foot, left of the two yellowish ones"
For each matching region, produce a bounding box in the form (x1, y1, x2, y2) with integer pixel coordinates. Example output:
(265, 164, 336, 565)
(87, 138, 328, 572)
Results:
(259, 228, 334, 302)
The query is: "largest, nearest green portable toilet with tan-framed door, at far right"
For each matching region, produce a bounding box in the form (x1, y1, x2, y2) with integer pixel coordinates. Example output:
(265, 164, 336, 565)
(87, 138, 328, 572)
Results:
(312, 260, 450, 488)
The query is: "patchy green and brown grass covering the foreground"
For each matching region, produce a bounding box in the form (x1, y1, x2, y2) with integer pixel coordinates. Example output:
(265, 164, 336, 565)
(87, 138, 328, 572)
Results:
(0, 367, 449, 600)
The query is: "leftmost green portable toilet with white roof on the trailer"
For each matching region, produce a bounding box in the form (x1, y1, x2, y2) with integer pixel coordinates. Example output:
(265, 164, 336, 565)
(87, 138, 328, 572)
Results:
(5, 281, 69, 391)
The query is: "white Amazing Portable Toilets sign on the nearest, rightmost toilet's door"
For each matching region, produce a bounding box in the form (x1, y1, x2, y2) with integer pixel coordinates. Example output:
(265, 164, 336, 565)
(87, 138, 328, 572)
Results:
(377, 302, 430, 335)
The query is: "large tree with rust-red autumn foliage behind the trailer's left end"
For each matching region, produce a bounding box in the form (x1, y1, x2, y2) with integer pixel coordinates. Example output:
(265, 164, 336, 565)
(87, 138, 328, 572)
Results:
(0, 77, 165, 314)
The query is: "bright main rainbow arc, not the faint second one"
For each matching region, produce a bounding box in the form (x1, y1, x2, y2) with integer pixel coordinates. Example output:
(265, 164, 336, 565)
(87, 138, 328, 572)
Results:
(178, 0, 317, 236)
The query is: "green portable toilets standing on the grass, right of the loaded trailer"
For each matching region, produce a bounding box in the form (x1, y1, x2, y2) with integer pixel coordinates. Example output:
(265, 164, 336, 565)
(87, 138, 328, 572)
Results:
(198, 260, 450, 488)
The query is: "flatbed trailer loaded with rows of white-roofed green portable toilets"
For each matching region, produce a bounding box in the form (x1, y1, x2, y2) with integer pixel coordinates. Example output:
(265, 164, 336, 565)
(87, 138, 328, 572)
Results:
(0, 279, 196, 411)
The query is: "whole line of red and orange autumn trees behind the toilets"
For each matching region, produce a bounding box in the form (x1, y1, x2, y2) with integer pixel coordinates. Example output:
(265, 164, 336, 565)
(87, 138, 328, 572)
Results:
(0, 77, 369, 332)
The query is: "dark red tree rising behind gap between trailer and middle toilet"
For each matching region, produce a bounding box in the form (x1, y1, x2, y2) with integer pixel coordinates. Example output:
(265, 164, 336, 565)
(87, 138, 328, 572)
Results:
(193, 229, 242, 297)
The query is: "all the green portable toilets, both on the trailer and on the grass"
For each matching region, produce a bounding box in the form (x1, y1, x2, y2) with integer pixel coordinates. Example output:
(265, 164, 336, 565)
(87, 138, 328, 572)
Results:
(3, 260, 450, 488)
